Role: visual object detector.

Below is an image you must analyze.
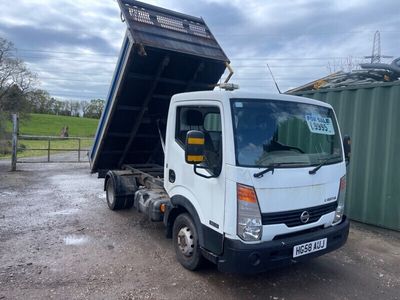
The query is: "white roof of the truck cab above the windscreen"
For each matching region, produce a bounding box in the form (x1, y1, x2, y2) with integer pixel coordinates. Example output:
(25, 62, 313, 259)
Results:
(172, 90, 332, 108)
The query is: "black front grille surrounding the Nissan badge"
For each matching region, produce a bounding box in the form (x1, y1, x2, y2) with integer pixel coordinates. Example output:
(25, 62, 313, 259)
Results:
(261, 201, 337, 227)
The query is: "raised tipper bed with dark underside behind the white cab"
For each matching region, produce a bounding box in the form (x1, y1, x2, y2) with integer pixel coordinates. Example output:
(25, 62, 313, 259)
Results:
(89, 0, 229, 172)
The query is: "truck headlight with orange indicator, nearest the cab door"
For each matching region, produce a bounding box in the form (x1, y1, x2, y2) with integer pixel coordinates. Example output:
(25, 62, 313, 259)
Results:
(236, 184, 262, 241)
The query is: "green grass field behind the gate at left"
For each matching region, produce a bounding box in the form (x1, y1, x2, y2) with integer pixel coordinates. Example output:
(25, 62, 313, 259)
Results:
(0, 114, 99, 159)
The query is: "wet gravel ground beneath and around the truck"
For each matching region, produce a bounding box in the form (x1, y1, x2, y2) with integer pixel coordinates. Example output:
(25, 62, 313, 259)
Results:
(0, 161, 400, 299)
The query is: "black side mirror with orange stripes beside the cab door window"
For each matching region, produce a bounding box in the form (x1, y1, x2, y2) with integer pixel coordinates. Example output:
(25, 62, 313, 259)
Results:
(185, 130, 205, 165)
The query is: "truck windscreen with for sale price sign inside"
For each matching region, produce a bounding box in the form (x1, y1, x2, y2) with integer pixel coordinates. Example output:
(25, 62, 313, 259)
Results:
(231, 99, 343, 167)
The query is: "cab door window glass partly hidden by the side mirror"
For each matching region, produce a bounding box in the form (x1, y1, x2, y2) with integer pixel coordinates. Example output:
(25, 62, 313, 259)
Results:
(175, 106, 222, 176)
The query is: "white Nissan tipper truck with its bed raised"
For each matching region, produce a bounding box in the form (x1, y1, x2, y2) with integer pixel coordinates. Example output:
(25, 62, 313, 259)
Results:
(90, 0, 350, 273)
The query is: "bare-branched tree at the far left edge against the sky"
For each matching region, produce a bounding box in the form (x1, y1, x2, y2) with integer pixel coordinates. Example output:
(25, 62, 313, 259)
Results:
(0, 38, 36, 112)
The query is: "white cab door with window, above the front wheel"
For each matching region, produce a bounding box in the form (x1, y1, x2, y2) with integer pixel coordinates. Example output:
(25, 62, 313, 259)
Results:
(165, 101, 225, 248)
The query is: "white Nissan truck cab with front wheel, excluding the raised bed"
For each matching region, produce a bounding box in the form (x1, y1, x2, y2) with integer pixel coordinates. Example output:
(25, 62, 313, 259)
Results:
(160, 91, 349, 273)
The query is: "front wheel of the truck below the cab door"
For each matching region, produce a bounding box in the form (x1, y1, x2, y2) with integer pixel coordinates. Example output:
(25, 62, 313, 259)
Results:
(172, 213, 203, 271)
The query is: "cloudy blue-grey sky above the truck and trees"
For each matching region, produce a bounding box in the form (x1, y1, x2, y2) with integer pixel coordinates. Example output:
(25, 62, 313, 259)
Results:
(0, 0, 400, 100)
